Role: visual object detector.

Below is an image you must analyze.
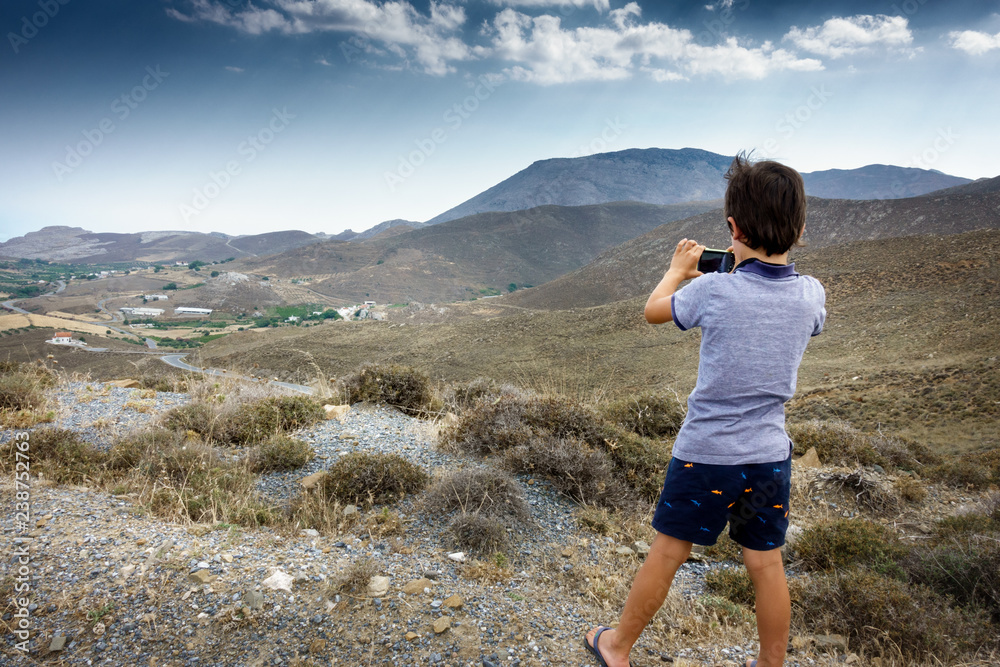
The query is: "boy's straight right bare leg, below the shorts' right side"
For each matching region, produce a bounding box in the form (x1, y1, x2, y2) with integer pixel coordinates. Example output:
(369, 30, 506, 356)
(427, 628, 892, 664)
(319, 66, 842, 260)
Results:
(744, 547, 792, 667)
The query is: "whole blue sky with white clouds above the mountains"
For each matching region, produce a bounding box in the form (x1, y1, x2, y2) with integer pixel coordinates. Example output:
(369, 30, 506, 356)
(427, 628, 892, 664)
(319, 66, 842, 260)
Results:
(0, 0, 1000, 240)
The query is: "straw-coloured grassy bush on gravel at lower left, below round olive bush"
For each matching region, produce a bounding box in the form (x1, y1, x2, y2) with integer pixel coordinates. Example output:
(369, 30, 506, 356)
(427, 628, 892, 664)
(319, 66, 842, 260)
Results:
(105, 429, 281, 527)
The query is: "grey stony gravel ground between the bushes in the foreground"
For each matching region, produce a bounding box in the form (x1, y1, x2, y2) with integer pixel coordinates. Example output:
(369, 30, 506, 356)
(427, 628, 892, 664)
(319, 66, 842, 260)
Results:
(0, 383, 827, 667)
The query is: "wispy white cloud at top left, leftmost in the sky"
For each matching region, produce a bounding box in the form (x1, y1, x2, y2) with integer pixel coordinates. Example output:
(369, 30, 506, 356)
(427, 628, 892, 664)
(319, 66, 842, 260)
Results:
(167, 0, 481, 75)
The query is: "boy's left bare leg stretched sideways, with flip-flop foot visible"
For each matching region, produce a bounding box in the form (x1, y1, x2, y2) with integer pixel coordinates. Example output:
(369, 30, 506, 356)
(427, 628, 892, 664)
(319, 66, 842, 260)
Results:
(587, 533, 691, 667)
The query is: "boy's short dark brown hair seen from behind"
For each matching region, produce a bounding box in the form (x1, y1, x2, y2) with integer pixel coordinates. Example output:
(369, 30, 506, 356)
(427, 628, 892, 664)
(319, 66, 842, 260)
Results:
(725, 153, 806, 255)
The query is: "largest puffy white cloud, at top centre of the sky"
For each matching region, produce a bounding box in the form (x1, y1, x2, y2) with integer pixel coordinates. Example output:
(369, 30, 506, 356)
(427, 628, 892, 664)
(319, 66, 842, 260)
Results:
(489, 2, 823, 85)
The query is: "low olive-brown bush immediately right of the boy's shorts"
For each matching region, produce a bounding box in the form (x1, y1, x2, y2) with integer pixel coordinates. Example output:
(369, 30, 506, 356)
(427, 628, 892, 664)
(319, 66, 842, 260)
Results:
(795, 519, 906, 572)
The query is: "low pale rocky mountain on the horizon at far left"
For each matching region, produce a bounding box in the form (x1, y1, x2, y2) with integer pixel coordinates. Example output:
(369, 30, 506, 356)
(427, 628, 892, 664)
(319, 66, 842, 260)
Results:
(0, 226, 320, 264)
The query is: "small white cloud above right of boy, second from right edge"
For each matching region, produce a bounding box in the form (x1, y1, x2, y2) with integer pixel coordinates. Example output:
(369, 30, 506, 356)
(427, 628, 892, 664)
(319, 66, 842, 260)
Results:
(784, 14, 914, 59)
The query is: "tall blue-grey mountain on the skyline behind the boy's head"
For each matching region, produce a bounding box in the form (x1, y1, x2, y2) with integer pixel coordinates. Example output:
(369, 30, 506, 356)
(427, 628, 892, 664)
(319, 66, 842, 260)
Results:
(428, 148, 969, 224)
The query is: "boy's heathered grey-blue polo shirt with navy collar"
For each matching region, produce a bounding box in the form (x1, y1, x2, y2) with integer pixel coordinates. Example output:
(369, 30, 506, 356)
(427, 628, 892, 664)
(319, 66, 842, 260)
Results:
(671, 259, 826, 465)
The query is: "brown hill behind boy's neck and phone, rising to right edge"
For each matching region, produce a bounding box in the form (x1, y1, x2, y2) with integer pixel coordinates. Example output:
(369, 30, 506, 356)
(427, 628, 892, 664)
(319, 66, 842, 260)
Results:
(504, 178, 1000, 309)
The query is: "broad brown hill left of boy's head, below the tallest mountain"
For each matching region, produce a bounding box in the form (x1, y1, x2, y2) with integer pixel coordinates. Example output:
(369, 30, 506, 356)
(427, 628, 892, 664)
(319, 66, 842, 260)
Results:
(239, 201, 719, 303)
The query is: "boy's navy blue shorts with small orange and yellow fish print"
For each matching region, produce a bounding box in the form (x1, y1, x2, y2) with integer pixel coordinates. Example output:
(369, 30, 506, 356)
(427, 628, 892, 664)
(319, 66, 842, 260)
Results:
(653, 453, 792, 551)
